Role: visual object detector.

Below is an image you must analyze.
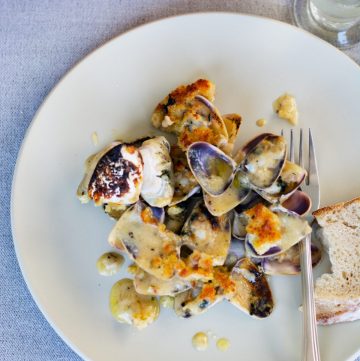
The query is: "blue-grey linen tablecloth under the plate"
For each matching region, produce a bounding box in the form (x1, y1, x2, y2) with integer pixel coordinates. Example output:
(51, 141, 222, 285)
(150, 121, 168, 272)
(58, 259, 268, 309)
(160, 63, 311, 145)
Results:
(0, 0, 360, 361)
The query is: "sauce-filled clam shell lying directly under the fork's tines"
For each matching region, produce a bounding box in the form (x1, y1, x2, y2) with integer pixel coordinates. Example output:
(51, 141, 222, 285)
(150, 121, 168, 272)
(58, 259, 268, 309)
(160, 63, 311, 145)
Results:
(257, 161, 307, 203)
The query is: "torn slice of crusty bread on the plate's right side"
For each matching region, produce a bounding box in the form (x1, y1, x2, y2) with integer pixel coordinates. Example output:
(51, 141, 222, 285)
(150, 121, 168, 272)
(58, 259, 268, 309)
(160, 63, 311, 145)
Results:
(313, 197, 360, 325)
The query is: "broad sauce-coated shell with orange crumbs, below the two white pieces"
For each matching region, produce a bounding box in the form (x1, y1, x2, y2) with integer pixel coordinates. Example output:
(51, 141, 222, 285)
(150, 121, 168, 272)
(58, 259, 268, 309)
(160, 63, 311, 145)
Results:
(109, 201, 181, 280)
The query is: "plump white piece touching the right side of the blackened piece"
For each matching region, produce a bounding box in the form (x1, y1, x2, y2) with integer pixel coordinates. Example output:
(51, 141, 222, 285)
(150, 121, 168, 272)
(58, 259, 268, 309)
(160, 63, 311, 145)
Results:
(139, 136, 174, 207)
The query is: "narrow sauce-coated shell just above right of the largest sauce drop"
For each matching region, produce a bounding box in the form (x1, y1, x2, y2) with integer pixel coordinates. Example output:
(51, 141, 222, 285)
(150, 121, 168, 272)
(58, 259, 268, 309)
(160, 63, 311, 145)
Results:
(134, 268, 191, 296)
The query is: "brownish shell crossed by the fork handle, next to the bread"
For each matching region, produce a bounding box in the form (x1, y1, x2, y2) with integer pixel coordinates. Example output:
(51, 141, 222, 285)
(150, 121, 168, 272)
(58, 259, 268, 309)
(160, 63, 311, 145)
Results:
(261, 239, 322, 275)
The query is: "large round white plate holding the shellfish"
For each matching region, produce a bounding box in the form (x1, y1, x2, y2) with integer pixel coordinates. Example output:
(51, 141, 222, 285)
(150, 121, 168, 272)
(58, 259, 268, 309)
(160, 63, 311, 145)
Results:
(12, 13, 360, 361)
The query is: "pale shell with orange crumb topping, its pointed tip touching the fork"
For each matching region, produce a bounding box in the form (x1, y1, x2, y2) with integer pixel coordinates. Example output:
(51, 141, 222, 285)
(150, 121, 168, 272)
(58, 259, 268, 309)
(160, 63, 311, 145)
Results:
(245, 207, 311, 258)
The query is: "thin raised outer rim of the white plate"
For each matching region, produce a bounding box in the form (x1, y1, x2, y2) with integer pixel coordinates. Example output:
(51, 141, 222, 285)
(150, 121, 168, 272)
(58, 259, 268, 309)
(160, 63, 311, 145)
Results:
(10, 11, 360, 361)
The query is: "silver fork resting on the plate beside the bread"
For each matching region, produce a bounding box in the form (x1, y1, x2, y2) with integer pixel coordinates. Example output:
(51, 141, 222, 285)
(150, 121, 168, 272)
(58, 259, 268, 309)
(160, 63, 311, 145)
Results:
(281, 129, 320, 361)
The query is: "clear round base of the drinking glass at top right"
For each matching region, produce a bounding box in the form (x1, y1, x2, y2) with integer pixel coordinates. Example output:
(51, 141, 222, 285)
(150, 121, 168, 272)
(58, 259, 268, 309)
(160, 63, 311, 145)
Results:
(293, 0, 360, 49)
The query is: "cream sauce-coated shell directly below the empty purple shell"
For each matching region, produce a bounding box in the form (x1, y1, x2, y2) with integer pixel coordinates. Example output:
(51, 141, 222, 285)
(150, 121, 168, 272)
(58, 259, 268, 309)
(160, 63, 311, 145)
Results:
(204, 171, 251, 216)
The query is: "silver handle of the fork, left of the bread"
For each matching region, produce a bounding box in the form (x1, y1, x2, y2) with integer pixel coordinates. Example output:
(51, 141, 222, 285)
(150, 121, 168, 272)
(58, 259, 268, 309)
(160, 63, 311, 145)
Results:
(300, 235, 320, 361)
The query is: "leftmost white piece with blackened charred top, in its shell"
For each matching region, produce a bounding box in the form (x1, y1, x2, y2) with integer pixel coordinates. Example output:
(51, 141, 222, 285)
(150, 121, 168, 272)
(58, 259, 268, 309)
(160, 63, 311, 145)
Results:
(77, 142, 143, 205)
